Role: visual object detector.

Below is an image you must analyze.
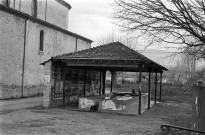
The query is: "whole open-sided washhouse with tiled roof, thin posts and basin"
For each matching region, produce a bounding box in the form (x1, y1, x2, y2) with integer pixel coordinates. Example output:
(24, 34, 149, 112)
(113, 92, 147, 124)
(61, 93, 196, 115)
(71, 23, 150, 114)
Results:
(42, 42, 167, 114)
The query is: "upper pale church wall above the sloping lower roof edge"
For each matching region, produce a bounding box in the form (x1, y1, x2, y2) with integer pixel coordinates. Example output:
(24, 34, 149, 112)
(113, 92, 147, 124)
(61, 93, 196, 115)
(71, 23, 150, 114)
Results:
(0, 0, 69, 30)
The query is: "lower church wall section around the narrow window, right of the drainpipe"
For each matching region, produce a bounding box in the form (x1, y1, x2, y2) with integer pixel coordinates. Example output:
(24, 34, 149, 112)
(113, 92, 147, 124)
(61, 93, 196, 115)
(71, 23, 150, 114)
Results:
(24, 21, 90, 97)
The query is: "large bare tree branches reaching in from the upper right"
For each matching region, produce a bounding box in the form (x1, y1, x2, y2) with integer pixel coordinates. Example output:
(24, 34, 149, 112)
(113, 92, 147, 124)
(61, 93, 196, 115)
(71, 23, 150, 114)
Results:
(114, 0, 205, 59)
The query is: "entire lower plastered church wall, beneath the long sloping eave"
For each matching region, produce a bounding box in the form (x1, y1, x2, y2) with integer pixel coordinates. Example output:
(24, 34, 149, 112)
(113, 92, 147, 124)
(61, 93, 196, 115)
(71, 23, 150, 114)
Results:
(0, 11, 90, 99)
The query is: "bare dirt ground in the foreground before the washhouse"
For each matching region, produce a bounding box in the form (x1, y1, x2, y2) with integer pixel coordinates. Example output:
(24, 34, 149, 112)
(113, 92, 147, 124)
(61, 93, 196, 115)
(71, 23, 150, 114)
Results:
(0, 96, 191, 135)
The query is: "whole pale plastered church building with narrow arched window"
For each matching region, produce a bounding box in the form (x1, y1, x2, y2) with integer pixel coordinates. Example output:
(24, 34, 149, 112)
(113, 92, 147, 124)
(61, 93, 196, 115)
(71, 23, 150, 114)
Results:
(0, 0, 92, 99)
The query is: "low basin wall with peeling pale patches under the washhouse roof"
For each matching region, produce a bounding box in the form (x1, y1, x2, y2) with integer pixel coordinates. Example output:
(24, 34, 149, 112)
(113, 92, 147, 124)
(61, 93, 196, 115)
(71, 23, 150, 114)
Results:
(78, 93, 148, 114)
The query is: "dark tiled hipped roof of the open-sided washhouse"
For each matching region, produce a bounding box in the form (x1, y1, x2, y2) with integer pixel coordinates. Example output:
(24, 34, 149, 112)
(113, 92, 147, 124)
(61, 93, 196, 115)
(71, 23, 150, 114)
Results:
(52, 42, 167, 70)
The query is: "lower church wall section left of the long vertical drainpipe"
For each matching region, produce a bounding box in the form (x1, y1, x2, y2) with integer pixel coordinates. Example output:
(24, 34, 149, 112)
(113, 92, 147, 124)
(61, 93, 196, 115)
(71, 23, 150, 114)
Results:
(0, 11, 25, 98)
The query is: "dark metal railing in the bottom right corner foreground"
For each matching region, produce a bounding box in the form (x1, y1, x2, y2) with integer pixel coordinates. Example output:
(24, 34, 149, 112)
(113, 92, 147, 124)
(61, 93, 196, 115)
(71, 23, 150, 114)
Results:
(161, 125, 205, 135)
